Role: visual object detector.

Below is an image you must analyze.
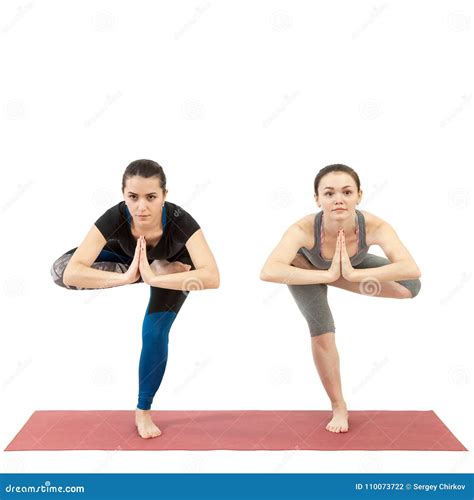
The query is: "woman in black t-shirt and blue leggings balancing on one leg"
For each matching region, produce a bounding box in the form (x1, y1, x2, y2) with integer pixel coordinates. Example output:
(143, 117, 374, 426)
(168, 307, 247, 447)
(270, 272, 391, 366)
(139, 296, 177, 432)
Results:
(51, 160, 219, 438)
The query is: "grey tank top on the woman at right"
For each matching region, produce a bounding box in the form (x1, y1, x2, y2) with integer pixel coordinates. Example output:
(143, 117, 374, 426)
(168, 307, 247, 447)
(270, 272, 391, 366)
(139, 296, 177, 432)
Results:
(298, 209, 369, 269)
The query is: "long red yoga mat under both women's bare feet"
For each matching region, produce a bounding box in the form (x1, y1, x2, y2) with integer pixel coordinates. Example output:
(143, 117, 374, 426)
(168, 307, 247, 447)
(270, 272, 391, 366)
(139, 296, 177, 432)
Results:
(5, 410, 467, 451)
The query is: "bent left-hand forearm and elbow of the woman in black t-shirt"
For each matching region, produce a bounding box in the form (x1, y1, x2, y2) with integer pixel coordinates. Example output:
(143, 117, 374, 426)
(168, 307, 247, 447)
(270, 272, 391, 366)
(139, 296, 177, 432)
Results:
(63, 225, 131, 288)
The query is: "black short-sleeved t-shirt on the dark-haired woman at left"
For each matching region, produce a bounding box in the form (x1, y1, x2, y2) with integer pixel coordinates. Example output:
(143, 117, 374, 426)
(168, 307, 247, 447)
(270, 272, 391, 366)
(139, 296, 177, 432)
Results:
(95, 201, 200, 265)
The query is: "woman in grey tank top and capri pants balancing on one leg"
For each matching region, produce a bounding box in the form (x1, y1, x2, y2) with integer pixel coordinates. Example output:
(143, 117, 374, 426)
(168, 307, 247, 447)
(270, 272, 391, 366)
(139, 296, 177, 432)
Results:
(260, 164, 421, 432)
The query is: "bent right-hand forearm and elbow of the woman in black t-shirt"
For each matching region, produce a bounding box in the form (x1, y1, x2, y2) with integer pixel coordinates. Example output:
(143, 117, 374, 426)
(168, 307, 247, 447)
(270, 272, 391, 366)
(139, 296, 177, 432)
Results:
(144, 229, 220, 291)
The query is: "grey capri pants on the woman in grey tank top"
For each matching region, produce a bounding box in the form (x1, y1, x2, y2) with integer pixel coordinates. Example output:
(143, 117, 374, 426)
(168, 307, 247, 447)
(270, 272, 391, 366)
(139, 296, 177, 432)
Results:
(288, 253, 421, 337)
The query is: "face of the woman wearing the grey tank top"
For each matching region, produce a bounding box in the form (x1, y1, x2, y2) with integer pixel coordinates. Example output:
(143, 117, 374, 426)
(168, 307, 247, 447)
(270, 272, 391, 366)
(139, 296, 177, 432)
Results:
(314, 172, 362, 219)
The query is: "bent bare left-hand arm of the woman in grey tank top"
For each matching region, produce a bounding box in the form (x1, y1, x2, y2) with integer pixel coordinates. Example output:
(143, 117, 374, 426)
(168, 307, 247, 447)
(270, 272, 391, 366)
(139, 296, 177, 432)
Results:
(260, 224, 337, 285)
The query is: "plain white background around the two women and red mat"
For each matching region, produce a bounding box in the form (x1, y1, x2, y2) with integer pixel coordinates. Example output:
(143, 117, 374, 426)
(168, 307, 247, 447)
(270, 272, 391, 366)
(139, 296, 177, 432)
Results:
(0, 0, 474, 472)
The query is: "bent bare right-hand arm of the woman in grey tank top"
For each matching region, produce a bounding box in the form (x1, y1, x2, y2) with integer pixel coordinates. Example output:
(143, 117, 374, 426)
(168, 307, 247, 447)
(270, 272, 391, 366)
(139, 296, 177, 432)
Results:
(349, 221, 421, 282)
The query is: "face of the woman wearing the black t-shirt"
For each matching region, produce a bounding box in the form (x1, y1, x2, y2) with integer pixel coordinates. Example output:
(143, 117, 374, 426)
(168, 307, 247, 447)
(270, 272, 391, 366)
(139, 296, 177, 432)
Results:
(123, 175, 166, 228)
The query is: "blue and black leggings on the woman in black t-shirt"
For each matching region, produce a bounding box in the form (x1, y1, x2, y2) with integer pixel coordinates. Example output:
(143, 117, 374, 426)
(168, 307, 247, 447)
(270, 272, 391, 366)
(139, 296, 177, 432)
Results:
(51, 240, 195, 410)
